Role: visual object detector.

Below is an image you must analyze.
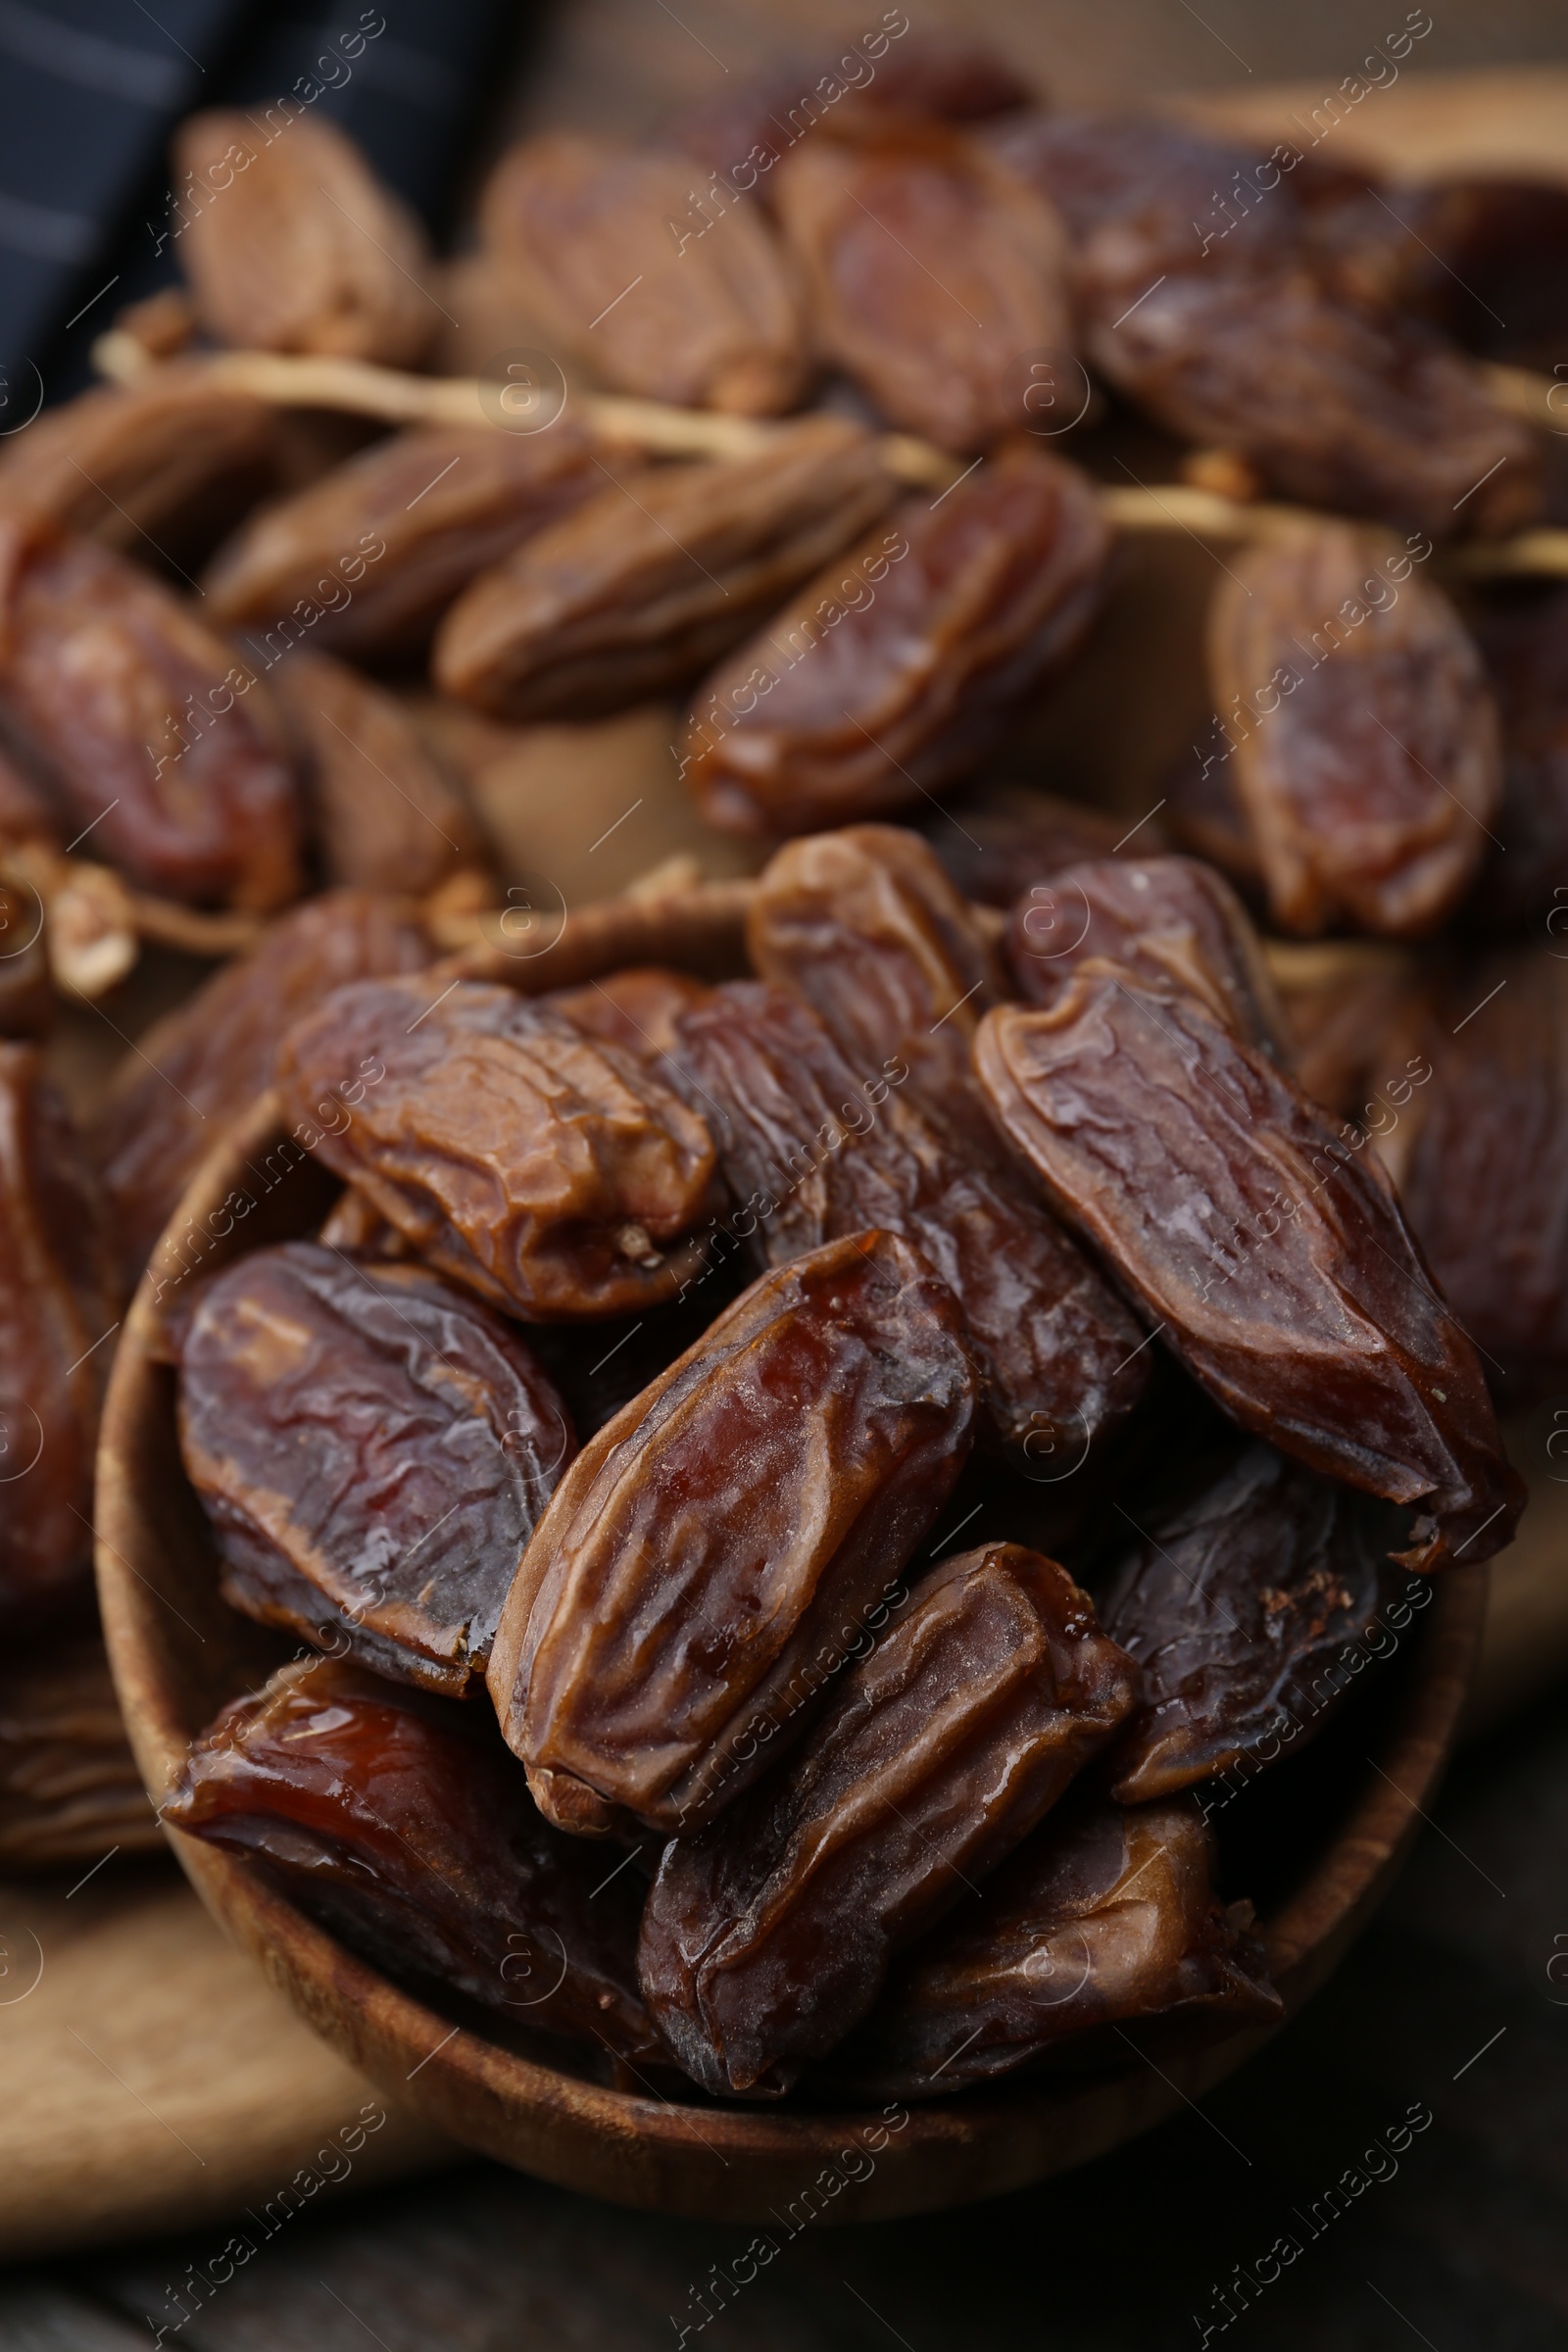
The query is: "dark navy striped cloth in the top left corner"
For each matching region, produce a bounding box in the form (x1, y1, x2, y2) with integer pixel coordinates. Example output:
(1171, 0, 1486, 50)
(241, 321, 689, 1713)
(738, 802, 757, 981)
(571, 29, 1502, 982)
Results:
(0, 0, 526, 414)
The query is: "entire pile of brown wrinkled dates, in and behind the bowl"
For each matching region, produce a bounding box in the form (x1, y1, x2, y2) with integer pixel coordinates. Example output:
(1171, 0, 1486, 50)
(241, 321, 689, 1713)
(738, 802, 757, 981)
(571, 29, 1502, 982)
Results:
(0, 31, 1568, 2103)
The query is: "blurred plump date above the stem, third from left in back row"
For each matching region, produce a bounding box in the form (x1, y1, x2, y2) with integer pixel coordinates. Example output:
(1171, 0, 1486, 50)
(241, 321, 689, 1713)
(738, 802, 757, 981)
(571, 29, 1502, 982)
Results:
(771, 127, 1074, 452)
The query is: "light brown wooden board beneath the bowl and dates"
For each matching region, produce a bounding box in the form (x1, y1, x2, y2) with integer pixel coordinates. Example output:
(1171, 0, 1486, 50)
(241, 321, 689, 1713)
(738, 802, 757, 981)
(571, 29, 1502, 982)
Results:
(0, 50, 1568, 2256)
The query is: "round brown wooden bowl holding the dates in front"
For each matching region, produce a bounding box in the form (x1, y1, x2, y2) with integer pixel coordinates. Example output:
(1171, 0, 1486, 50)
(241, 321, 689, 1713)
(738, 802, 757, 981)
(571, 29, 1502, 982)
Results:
(99, 884, 1486, 2228)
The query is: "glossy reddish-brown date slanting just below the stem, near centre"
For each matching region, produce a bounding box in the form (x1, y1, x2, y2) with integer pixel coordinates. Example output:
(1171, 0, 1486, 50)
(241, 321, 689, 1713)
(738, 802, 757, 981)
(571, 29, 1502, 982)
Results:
(684, 437, 1109, 833)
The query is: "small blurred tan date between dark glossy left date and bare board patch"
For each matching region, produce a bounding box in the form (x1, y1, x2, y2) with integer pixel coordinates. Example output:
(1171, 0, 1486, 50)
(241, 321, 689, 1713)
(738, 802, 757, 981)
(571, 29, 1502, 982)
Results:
(275, 647, 479, 896)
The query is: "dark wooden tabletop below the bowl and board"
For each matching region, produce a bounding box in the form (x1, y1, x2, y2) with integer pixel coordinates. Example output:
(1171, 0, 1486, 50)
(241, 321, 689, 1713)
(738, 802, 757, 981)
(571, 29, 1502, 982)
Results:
(0, 1695, 1568, 2352)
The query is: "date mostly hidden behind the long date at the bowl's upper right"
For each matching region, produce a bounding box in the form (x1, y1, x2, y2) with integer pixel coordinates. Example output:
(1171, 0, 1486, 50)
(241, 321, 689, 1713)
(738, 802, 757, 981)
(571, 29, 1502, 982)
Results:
(1006, 858, 1286, 1060)
